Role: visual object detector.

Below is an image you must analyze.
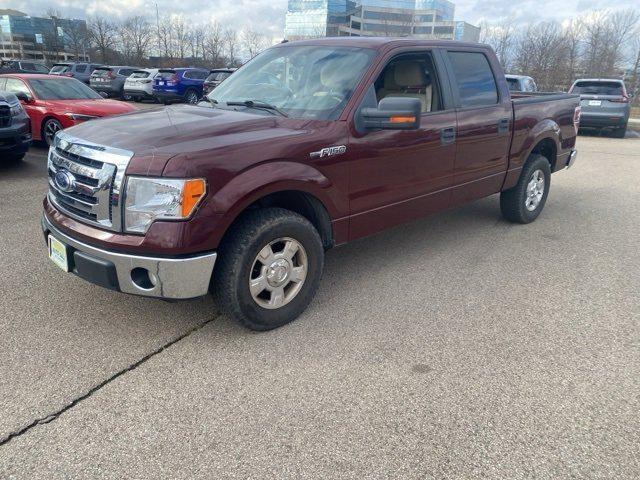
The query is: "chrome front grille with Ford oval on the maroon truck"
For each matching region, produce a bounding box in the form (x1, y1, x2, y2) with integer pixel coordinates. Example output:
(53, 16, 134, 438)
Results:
(47, 132, 133, 231)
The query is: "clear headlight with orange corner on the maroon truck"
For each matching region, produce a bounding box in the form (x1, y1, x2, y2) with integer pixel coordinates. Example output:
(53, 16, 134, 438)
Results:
(124, 177, 207, 233)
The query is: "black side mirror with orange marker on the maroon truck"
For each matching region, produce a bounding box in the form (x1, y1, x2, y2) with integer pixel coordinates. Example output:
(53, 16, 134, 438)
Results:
(361, 97, 422, 130)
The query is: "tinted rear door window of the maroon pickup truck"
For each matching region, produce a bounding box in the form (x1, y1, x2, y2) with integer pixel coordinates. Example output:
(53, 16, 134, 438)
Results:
(448, 52, 498, 107)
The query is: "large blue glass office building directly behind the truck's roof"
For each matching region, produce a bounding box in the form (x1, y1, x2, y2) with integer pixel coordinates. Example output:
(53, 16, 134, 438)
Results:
(285, 0, 480, 42)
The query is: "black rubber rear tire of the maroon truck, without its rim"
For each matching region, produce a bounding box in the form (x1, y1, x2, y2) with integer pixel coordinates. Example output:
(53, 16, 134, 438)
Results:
(500, 155, 551, 223)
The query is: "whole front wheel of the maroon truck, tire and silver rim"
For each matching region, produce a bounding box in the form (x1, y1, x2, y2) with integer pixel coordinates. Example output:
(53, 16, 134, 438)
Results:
(212, 208, 324, 330)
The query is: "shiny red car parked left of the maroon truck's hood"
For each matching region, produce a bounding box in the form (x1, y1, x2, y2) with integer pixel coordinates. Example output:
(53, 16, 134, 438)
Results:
(0, 74, 137, 145)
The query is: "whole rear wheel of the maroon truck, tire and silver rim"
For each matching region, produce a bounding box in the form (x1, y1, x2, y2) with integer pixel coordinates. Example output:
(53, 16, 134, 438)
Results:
(500, 155, 551, 223)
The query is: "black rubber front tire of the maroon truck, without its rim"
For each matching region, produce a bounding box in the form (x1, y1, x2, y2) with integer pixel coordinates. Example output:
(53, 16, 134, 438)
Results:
(211, 208, 324, 331)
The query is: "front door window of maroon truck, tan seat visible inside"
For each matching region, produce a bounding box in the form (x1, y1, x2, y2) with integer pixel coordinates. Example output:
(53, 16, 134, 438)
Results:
(374, 52, 442, 113)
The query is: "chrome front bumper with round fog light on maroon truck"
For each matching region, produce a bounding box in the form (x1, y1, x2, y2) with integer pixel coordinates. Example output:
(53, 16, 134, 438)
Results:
(42, 215, 217, 299)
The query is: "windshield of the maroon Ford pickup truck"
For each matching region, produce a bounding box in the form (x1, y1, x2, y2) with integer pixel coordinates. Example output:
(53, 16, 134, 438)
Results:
(207, 45, 374, 120)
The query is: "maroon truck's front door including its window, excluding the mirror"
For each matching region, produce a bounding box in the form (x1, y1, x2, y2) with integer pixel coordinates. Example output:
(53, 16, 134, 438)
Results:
(349, 50, 456, 239)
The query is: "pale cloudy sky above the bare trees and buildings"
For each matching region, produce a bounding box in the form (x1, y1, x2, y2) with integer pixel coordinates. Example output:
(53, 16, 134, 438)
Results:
(1, 0, 638, 39)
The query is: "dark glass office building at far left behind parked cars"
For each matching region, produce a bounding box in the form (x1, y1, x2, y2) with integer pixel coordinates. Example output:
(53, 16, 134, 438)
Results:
(0, 9, 88, 61)
